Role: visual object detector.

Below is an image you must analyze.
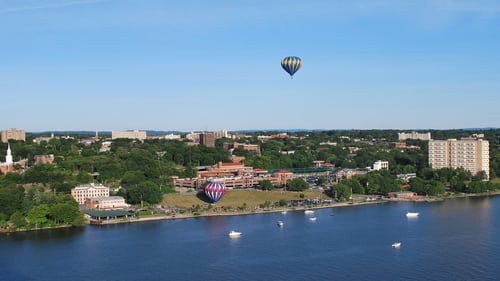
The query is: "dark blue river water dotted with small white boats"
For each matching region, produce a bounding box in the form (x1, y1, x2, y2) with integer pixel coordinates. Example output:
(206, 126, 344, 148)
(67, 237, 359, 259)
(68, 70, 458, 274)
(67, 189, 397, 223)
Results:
(0, 196, 500, 281)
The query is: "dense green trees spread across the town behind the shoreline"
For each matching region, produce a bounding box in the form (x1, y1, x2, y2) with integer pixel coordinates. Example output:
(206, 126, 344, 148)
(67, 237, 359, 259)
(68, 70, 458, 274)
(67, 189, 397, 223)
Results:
(0, 129, 500, 228)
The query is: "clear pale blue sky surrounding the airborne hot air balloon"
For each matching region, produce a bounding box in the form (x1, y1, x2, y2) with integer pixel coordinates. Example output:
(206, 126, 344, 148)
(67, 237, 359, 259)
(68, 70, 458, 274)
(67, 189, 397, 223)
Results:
(0, 0, 500, 132)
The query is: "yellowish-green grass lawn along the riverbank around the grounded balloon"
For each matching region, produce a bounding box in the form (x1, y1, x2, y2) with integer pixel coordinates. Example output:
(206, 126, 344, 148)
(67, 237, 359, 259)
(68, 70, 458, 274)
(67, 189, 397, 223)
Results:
(162, 189, 332, 209)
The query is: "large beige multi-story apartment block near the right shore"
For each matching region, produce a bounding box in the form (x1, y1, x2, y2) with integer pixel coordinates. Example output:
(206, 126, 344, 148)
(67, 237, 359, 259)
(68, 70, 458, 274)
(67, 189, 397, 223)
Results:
(429, 138, 490, 178)
